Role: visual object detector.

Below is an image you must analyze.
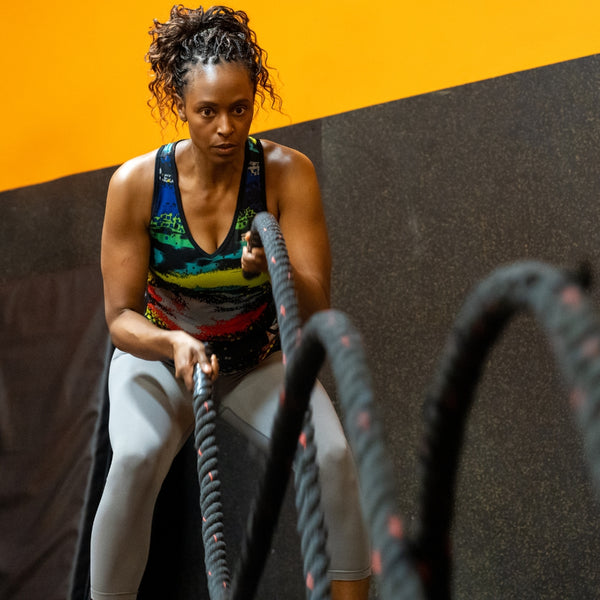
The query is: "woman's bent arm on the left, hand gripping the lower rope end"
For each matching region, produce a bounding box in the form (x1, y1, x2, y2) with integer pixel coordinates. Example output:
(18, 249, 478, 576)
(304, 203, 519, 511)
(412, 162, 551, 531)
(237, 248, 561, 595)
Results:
(101, 153, 218, 389)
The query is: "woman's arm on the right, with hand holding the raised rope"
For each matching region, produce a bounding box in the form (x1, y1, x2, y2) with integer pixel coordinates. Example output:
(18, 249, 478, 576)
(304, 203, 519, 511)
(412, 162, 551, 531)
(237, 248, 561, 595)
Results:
(241, 140, 331, 320)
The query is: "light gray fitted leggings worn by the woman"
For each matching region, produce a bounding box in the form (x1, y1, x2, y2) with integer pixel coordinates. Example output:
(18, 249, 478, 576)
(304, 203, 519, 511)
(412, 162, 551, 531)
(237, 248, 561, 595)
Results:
(91, 350, 370, 600)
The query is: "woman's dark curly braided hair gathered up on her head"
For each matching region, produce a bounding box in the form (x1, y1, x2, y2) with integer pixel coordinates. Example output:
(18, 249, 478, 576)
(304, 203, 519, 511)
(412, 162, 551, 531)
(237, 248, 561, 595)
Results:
(146, 4, 281, 123)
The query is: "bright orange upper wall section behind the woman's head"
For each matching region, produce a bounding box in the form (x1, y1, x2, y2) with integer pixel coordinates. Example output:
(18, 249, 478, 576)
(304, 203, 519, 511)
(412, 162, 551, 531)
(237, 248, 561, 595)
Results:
(0, 0, 600, 190)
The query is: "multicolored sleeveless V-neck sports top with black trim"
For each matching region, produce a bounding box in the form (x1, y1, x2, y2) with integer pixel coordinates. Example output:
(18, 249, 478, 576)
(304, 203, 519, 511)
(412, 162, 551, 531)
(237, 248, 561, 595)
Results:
(146, 137, 280, 373)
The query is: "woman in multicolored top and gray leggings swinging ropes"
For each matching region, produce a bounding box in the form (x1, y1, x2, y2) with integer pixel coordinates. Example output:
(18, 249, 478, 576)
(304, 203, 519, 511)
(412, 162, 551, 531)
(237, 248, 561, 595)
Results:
(91, 6, 369, 600)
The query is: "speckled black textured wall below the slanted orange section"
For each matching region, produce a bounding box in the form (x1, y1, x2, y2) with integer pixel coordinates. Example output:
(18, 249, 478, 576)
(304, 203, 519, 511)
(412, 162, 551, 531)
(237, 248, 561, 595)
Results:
(0, 56, 600, 600)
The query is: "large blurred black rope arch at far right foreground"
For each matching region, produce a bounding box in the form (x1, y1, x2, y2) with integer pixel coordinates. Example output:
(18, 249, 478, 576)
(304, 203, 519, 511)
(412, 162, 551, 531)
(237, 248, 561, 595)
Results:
(412, 262, 600, 600)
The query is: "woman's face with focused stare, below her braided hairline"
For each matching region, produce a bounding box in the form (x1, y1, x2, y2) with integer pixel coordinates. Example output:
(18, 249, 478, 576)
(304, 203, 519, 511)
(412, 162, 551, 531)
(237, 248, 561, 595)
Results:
(177, 62, 254, 161)
